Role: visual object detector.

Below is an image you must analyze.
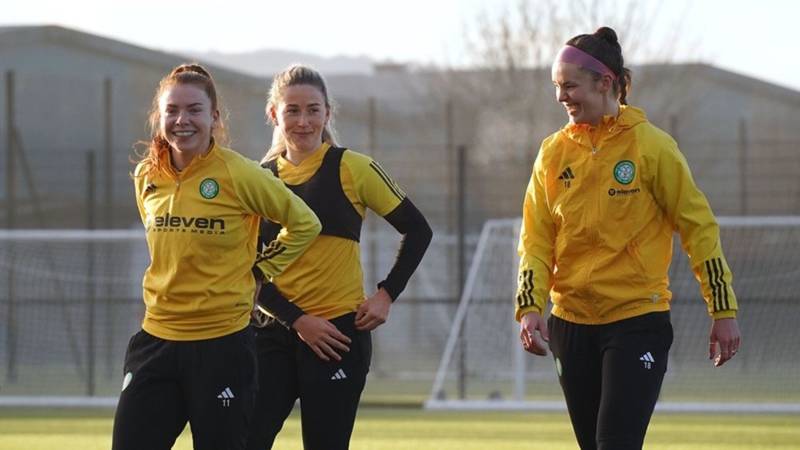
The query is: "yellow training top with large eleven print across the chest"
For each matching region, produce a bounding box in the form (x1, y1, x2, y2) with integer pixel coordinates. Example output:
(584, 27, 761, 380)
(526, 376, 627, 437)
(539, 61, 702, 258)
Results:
(134, 145, 320, 341)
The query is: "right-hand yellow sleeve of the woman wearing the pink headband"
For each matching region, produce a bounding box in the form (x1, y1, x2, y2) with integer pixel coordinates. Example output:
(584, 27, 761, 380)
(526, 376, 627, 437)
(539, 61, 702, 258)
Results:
(653, 139, 738, 319)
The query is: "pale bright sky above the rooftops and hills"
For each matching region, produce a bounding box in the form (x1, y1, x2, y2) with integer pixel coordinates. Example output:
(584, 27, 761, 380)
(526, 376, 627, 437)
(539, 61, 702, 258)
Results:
(0, 0, 800, 90)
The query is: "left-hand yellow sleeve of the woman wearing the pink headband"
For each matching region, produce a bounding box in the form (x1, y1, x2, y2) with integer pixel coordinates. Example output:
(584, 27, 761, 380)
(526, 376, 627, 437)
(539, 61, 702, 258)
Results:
(515, 150, 556, 320)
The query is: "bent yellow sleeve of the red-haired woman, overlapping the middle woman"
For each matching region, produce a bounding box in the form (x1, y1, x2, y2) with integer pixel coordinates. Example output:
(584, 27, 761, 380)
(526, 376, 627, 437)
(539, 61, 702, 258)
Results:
(232, 156, 322, 280)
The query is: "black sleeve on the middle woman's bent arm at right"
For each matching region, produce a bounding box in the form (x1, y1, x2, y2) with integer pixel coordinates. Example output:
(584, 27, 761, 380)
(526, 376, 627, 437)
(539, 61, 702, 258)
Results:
(378, 197, 433, 301)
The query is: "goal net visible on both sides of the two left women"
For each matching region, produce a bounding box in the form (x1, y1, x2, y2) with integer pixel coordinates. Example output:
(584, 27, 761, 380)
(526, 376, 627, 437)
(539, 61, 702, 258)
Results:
(0, 223, 454, 406)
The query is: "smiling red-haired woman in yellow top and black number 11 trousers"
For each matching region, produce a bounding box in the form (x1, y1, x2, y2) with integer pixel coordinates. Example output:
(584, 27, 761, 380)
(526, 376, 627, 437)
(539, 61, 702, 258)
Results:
(112, 64, 320, 450)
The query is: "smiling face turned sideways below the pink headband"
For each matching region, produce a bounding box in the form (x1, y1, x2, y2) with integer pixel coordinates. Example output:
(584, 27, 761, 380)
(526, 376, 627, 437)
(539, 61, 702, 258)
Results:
(552, 62, 613, 125)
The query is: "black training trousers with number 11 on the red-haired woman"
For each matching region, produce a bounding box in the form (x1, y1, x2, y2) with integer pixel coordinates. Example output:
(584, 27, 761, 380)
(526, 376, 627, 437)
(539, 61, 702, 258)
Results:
(112, 327, 257, 450)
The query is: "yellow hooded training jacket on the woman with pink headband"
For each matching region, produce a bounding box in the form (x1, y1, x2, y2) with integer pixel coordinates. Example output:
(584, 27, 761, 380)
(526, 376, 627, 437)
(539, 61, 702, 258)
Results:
(516, 106, 737, 324)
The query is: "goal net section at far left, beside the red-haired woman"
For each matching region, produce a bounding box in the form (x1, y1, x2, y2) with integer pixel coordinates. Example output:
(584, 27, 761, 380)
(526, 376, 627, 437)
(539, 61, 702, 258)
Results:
(0, 230, 149, 406)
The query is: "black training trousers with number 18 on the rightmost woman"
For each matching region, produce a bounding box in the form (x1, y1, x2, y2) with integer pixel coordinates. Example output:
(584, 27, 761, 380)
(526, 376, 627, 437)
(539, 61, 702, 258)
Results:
(548, 312, 672, 450)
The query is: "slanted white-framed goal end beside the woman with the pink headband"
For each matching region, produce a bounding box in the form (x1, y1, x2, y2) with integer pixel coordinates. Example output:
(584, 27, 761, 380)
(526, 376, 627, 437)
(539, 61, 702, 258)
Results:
(425, 218, 563, 410)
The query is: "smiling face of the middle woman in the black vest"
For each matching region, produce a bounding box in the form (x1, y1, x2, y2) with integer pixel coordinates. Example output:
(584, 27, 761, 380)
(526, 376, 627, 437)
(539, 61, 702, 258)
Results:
(270, 84, 330, 154)
